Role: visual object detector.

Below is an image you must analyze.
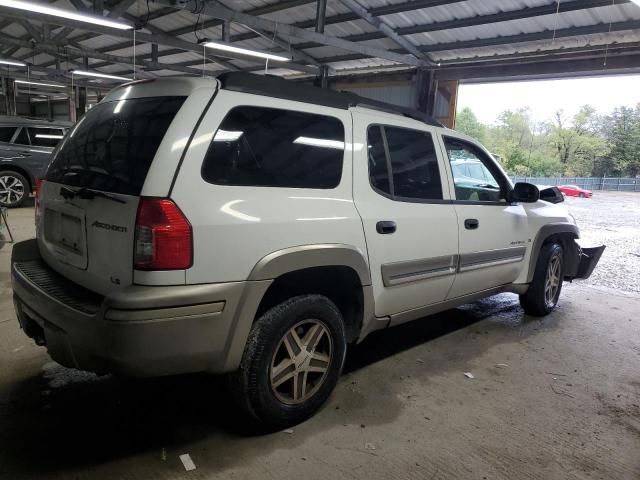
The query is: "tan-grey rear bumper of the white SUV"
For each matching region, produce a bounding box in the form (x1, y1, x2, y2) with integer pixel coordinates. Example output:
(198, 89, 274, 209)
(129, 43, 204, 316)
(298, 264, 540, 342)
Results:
(11, 240, 271, 376)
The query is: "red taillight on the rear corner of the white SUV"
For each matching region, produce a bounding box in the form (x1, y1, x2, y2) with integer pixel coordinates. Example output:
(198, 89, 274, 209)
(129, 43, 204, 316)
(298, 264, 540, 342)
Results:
(133, 198, 193, 270)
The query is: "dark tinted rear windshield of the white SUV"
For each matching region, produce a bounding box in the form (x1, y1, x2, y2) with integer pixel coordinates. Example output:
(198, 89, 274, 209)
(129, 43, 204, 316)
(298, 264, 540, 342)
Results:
(46, 97, 186, 195)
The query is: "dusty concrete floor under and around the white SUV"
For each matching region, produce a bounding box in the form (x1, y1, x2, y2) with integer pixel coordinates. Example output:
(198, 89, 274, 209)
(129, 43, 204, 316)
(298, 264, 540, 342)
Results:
(0, 197, 640, 480)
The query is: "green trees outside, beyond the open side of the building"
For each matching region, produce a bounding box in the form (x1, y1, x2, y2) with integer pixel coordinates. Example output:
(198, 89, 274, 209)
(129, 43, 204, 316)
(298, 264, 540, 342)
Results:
(456, 104, 640, 176)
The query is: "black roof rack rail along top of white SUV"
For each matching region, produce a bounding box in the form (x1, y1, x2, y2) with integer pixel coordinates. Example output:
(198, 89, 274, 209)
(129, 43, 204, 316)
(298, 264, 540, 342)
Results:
(218, 72, 443, 127)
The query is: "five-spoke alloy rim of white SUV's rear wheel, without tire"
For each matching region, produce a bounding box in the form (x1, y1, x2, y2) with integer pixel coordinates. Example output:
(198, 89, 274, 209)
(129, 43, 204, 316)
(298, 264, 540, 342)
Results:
(269, 319, 333, 405)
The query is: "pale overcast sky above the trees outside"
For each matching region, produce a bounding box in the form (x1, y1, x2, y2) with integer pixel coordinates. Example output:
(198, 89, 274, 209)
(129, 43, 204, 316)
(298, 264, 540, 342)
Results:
(458, 75, 640, 124)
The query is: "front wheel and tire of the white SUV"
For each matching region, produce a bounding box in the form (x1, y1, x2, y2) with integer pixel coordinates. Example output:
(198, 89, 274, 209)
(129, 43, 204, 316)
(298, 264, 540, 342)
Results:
(520, 243, 564, 317)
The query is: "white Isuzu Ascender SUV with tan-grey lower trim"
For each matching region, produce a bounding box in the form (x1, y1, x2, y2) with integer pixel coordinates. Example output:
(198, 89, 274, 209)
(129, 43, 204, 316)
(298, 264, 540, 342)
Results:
(12, 73, 604, 427)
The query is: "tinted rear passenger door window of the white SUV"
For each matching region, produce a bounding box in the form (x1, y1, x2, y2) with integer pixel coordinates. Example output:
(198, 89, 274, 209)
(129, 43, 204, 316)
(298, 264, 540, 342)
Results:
(368, 125, 443, 201)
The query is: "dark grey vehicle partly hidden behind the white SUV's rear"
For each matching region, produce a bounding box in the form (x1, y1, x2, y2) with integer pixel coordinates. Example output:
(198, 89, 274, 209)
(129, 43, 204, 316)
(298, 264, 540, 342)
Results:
(0, 115, 72, 207)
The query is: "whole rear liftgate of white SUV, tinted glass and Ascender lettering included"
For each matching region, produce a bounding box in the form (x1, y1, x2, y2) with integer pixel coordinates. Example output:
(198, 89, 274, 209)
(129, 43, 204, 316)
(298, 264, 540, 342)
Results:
(37, 97, 186, 295)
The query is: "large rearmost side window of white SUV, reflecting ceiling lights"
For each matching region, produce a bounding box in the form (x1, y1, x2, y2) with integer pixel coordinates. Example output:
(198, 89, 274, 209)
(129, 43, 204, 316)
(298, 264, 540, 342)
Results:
(202, 107, 344, 189)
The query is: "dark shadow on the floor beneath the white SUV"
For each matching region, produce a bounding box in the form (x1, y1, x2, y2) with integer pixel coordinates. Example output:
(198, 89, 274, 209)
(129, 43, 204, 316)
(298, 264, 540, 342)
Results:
(0, 297, 530, 478)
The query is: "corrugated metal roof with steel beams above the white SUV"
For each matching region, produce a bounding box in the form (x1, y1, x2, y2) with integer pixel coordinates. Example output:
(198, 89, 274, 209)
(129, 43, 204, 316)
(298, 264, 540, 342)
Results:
(0, 0, 640, 125)
